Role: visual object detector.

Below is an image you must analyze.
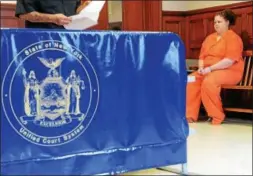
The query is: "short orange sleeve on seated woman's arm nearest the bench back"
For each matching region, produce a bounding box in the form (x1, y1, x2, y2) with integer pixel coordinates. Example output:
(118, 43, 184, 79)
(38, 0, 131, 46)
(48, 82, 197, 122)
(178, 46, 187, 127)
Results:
(224, 36, 243, 61)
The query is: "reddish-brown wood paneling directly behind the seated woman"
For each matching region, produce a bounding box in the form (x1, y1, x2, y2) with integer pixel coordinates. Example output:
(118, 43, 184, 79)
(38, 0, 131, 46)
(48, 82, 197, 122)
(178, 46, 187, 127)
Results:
(162, 1, 253, 59)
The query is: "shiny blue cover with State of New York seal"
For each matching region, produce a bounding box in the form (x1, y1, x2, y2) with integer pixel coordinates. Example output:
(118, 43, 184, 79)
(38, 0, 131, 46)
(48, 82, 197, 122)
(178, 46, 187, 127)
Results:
(1, 29, 189, 175)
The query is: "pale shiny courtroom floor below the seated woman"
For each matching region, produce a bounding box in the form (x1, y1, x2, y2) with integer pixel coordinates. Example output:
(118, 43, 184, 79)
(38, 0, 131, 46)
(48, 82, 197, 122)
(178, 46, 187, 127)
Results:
(122, 122, 252, 175)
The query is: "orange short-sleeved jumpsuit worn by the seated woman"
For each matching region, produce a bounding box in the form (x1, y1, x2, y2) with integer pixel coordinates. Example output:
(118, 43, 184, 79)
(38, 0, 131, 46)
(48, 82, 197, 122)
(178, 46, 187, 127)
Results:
(186, 30, 244, 124)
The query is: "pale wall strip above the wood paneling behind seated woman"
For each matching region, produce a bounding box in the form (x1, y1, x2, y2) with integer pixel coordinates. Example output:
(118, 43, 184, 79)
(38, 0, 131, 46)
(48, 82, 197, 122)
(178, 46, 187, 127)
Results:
(162, 0, 250, 11)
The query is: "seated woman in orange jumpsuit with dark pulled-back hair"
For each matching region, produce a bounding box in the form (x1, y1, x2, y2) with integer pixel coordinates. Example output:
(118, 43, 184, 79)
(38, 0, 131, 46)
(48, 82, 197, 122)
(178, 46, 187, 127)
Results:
(186, 9, 244, 125)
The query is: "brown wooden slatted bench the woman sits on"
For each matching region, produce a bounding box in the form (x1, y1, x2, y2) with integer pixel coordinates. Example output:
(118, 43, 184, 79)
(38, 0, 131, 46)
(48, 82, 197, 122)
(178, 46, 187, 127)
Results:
(222, 50, 253, 113)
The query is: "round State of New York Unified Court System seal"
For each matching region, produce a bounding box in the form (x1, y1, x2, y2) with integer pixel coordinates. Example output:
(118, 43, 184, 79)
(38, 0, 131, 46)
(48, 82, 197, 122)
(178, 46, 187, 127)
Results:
(1, 40, 99, 146)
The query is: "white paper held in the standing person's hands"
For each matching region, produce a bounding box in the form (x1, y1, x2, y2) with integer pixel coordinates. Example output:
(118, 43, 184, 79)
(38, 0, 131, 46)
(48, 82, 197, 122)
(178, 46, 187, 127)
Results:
(64, 0, 105, 30)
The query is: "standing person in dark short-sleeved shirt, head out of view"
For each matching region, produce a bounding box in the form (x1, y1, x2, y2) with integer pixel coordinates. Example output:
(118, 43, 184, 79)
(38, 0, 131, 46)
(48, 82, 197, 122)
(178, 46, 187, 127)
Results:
(15, 0, 90, 29)
